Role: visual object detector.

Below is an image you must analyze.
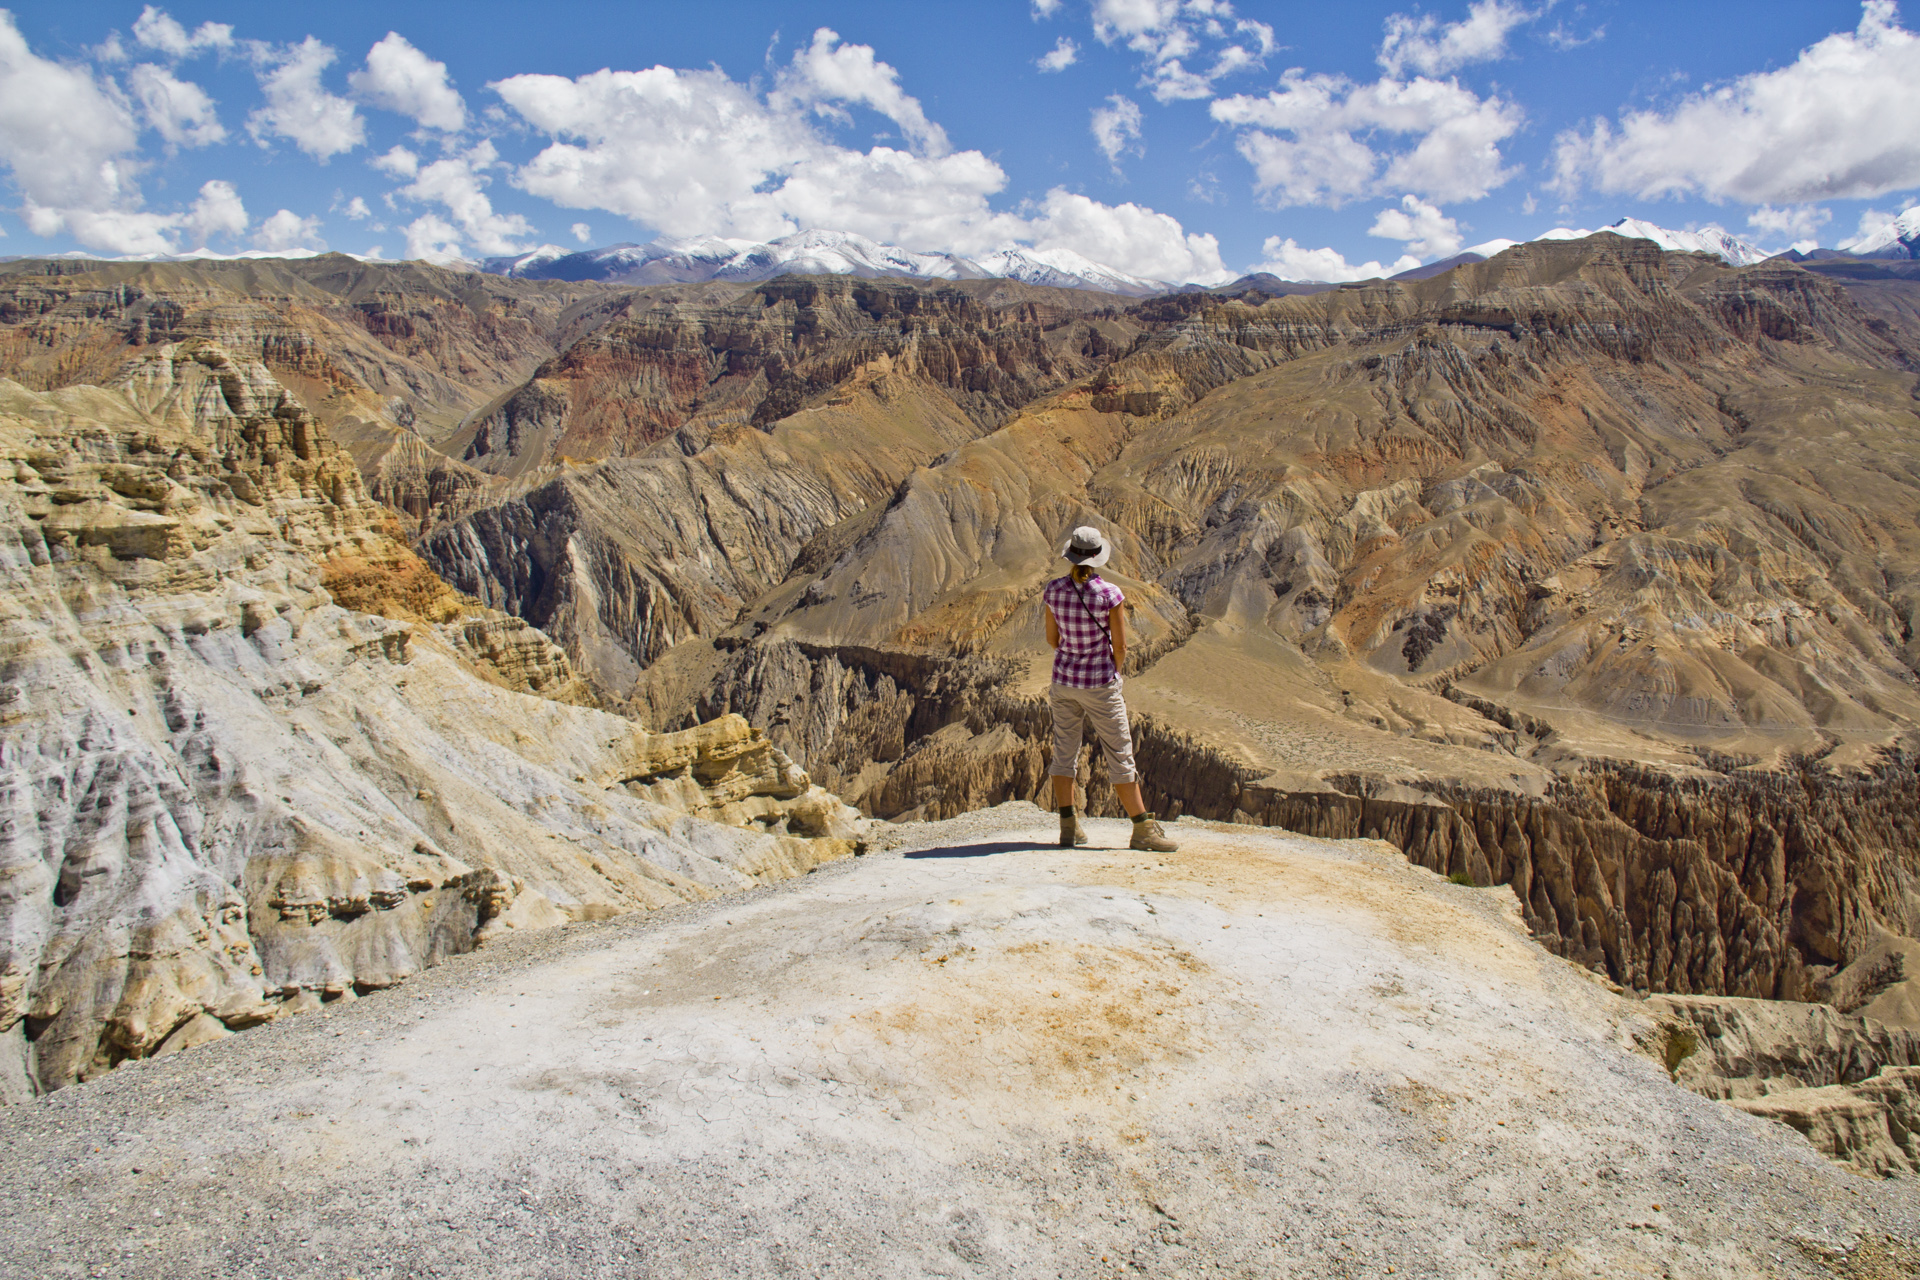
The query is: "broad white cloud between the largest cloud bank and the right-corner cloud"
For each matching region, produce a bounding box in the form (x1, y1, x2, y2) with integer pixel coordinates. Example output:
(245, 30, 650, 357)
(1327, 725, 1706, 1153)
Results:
(1208, 71, 1524, 207)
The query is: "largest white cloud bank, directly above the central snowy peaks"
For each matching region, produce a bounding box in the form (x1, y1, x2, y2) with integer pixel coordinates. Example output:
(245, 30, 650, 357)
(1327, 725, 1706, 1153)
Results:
(491, 50, 1231, 284)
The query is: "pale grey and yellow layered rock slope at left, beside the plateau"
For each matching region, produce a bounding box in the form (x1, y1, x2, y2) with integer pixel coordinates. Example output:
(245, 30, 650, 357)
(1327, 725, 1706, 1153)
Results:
(0, 342, 854, 1098)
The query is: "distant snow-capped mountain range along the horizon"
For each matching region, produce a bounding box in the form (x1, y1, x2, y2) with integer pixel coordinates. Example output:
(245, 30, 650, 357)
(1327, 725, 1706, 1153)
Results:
(18, 205, 1920, 297)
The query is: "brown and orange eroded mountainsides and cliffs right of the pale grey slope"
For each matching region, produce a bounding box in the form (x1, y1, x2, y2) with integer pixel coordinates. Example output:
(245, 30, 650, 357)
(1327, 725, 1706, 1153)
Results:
(11, 234, 1920, 1043)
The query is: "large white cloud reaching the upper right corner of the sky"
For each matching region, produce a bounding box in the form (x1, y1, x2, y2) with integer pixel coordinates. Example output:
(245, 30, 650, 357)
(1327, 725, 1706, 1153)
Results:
(1553, 0, 1920, 203)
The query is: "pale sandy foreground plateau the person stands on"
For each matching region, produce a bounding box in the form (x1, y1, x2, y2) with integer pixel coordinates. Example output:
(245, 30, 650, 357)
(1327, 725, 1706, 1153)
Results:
(0, 804, 1920, 1280)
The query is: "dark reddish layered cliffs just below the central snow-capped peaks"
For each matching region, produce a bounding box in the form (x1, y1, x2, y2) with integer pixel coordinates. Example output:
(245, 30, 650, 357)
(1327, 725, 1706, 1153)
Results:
(449, 276, 1140, 474)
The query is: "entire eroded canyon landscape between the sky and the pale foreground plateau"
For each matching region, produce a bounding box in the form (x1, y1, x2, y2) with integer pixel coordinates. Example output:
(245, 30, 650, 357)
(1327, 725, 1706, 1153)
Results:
(0, 234, 1920, 1182)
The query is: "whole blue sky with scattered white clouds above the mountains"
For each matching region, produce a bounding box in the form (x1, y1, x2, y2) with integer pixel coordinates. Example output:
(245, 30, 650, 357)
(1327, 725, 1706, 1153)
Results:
(0, 0, 1920, 280)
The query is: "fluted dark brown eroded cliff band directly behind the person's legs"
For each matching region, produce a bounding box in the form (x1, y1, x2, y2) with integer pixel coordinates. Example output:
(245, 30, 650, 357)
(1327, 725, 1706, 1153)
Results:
(656, 643, 1920, 1007)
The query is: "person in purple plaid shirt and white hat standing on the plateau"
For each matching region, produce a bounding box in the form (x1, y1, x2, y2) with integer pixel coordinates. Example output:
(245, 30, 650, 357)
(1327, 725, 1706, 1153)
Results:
(1041, 524, 1179, 854)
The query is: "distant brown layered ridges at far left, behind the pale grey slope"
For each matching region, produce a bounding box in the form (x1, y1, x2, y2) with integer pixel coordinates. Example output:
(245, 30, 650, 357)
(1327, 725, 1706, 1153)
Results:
(0, 253, 609, 537)
